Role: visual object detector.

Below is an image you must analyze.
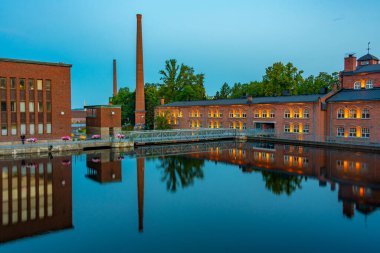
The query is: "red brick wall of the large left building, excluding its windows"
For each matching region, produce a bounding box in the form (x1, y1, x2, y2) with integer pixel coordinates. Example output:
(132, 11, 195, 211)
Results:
(0, 61, 71, 141)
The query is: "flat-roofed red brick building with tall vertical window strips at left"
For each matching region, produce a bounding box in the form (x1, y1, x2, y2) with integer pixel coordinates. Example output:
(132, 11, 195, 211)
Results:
(0, 59, 71, 141)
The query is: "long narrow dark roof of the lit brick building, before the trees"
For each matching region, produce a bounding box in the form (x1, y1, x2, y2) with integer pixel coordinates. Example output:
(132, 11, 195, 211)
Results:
(159, 94, 326, 107)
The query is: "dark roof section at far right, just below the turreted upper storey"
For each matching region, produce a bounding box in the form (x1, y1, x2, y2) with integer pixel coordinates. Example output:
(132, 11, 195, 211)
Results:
(327, 88, 380, 102)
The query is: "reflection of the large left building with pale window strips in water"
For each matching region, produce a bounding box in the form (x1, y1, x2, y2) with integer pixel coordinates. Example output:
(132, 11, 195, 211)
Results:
(0, 156, 73, 243)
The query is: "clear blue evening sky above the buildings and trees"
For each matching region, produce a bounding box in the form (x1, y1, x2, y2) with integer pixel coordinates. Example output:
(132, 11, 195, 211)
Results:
(0, 0, 380, 108)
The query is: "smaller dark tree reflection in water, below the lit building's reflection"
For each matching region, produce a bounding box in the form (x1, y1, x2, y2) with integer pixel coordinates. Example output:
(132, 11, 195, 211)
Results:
(261, 171, 303, 196)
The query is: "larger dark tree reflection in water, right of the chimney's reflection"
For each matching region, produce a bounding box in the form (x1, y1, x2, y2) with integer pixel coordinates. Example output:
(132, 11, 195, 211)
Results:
(158, 156, 204, 192)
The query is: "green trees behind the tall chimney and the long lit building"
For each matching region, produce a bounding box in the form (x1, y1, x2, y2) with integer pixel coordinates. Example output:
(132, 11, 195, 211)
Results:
(112, 59, 339, 129)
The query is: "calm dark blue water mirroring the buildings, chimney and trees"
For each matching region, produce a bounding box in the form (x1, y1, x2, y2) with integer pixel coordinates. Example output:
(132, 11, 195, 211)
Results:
(0, 142, 380, 253)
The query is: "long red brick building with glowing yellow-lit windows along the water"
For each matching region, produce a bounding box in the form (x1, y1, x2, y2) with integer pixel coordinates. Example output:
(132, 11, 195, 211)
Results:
(155, 50, 380, 143)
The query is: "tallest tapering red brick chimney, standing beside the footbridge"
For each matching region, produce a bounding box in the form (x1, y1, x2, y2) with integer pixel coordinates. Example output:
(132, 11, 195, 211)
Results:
(135, 14, 145, 130)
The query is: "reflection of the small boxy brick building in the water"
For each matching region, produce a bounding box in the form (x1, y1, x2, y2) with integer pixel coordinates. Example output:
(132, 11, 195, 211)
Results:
(86, 149, 124, 183)
